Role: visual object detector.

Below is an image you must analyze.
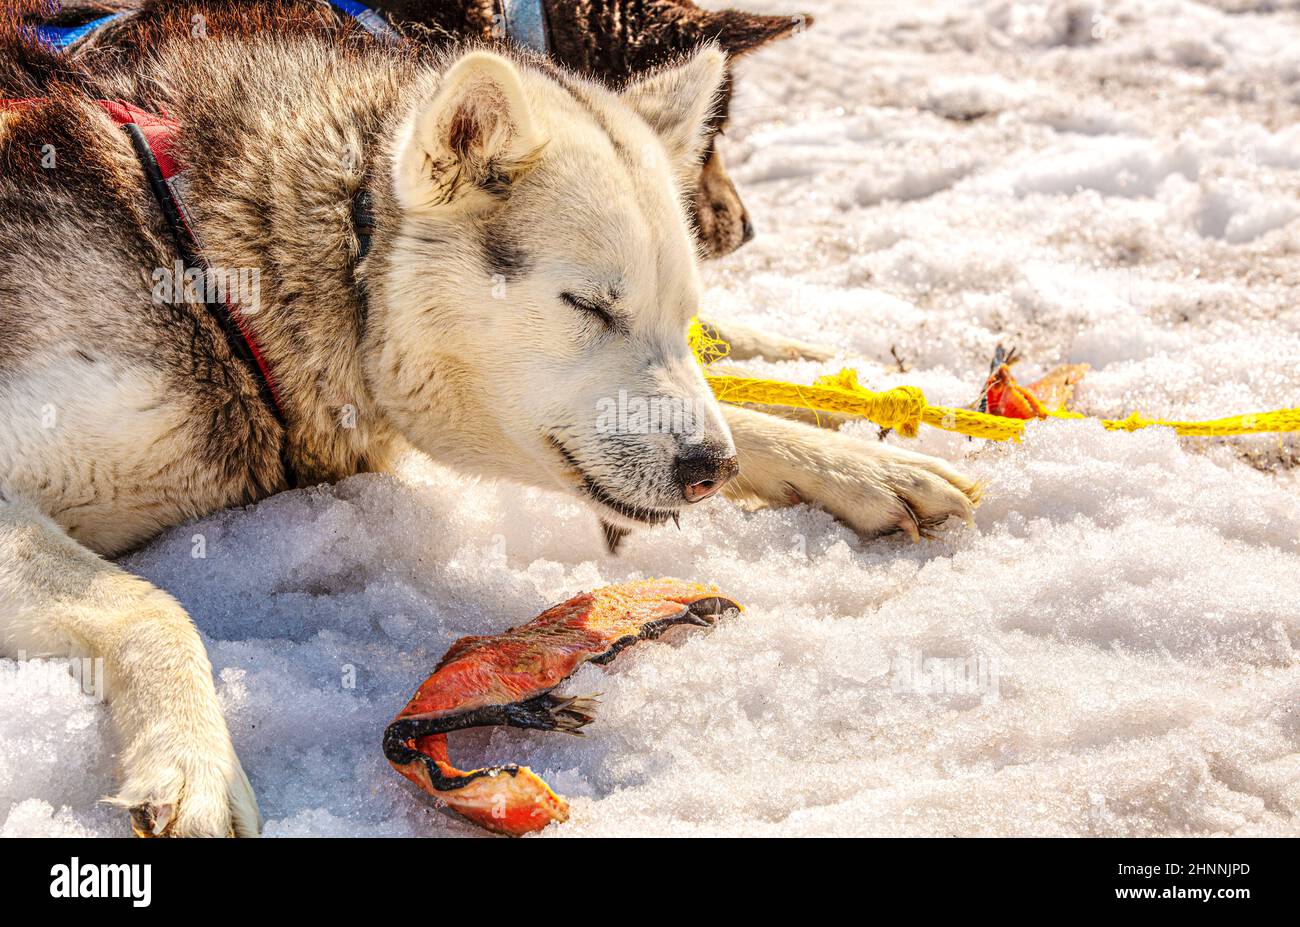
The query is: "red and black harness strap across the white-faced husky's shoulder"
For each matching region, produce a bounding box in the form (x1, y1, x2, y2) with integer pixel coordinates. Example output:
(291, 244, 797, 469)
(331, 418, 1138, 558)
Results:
(0, 99, 287, 432)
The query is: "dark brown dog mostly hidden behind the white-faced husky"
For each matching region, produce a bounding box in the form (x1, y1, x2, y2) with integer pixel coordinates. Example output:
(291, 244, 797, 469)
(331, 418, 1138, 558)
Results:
(26, 0, 811, 257)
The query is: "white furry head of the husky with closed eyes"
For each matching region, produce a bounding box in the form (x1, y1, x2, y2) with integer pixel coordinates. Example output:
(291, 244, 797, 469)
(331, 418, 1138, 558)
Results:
(368, 49, 733, 524)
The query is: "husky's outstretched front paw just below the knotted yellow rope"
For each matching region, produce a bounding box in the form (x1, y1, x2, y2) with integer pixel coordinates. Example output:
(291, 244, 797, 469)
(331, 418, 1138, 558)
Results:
(789, 432, 982, 541)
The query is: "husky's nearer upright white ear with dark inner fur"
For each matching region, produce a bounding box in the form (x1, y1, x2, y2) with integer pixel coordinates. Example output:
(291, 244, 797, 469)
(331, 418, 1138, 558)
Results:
(395, 51, 546, 209)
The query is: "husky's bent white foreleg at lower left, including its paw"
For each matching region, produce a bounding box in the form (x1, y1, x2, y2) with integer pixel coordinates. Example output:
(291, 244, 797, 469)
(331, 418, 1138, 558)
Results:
(0, 499, 260, 836)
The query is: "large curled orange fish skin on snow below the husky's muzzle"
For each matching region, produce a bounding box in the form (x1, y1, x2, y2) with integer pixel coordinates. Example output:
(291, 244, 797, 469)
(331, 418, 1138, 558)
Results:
(384, 579, 741, 836)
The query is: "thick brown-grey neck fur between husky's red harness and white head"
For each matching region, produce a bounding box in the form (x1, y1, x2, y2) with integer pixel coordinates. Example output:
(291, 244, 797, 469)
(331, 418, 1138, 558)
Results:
(135, 34, 436, 482)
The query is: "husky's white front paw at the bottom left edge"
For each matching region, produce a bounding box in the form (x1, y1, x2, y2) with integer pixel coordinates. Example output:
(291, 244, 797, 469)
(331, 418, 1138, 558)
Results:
(108, 722, 261, 837)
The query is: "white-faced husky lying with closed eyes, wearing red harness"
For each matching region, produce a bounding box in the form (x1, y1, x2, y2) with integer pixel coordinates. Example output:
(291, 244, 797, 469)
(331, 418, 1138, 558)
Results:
(0, 38, 975, 835)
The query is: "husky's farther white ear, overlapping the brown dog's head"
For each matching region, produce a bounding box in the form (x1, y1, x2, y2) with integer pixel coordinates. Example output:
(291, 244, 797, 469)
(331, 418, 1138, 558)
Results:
(620, 44, 727, 182)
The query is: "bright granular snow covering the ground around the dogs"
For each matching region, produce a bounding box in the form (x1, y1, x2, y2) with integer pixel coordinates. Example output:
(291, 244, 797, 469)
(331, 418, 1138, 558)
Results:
(0, 0, 1300, 837)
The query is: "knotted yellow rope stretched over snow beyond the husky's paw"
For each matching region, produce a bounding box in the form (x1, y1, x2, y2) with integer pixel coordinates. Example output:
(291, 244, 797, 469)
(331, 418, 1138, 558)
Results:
(690, 320, 1300, 441)
